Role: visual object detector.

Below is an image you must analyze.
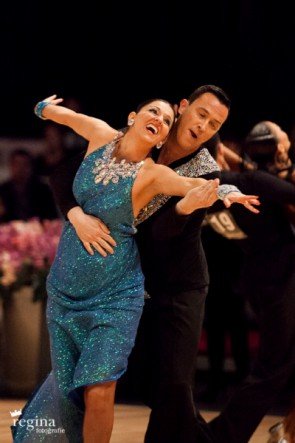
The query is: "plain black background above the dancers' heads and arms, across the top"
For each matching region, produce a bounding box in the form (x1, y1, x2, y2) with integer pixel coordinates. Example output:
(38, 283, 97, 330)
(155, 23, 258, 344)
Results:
(0, 0, 295, 137)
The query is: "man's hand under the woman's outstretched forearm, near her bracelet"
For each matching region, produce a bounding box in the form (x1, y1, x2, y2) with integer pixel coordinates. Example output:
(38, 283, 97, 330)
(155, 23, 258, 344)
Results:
(176, 179, 219, 215)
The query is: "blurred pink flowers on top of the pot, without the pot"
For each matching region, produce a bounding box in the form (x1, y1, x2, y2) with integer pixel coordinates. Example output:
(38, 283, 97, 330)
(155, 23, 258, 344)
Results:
(0, 219, 63, 298)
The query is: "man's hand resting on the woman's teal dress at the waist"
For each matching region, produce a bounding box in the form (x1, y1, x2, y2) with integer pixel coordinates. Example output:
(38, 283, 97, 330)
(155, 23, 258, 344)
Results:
(67, 206, 117, 257)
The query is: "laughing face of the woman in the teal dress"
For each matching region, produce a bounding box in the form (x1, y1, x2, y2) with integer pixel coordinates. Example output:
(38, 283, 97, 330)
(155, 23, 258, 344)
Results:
(133, 100, 174, 146)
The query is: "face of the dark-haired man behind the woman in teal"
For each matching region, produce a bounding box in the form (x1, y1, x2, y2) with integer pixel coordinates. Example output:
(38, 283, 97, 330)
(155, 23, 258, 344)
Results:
(176, 92, 229, 153)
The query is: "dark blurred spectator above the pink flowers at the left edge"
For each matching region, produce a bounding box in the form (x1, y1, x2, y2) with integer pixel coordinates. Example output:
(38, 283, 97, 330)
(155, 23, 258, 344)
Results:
(0, 149, 58, 223)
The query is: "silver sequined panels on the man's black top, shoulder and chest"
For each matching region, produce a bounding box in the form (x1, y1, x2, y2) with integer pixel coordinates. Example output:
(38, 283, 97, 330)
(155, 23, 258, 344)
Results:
(135, 148, 220, 225)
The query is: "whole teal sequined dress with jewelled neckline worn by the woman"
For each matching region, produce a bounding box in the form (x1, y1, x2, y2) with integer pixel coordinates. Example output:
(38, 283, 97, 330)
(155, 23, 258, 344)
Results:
(13, 134, 144, 443)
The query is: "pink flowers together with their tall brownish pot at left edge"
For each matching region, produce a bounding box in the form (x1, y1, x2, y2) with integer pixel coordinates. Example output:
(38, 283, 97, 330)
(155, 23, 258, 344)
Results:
(0, 219, 63, 395)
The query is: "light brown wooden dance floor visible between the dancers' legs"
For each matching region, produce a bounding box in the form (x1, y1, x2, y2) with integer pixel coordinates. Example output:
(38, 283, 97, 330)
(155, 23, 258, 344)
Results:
(0, 399, 281, 443)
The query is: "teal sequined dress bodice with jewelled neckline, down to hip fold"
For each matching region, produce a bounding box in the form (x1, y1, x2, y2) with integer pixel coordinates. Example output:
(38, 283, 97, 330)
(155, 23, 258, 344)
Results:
(47, 141, 143, 309)
